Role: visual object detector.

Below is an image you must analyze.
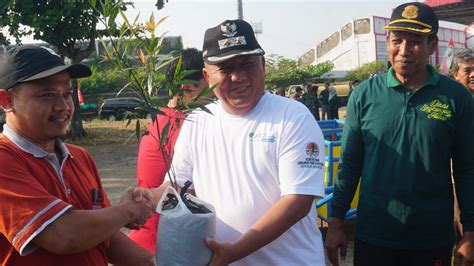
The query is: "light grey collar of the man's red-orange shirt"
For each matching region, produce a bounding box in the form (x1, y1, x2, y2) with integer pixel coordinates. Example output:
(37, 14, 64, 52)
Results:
(2, 124, 72, 158)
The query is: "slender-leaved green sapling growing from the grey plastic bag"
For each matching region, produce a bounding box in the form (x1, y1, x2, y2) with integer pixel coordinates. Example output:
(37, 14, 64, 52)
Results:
(90, 0, 215, 189)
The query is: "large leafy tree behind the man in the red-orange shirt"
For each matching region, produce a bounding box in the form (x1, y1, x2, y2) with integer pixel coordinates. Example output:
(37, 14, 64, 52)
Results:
(0, 0, 168, 138)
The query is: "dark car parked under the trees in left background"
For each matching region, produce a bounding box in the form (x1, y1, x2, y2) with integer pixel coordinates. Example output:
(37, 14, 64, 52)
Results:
(99, 97, 140, 121)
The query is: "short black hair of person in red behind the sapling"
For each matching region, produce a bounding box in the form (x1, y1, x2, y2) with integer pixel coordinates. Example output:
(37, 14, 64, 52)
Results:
(165, 48, 204, 83)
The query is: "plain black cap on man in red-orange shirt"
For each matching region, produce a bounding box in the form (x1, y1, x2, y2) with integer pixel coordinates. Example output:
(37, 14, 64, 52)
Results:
(0, 45, 92, 89)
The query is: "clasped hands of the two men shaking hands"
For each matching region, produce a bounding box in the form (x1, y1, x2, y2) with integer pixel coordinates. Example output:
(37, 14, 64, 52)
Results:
(117, 187, 156, 229)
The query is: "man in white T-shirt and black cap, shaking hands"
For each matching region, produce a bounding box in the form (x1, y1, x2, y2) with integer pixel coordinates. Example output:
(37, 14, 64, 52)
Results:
(156, 20, 325, 265)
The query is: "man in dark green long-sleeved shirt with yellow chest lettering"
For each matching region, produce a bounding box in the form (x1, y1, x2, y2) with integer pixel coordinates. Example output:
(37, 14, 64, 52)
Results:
(326, 2, 474, 266)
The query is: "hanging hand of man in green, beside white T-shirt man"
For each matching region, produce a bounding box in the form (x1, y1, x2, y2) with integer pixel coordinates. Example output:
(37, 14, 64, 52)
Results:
(325, 218, 347, 266)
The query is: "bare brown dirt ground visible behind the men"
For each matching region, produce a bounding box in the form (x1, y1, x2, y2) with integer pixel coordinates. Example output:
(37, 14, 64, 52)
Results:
(76, 115, 354, 266)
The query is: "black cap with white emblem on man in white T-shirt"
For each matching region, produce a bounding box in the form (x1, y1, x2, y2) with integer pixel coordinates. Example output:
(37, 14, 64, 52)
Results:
(202, 19, 265, 65)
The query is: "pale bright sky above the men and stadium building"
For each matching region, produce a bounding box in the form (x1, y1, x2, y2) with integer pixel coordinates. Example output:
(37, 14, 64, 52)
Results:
(128, 0, 464, 59)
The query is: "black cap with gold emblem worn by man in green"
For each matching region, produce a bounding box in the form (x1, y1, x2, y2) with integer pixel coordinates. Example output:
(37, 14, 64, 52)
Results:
(383, 2, 439, 35)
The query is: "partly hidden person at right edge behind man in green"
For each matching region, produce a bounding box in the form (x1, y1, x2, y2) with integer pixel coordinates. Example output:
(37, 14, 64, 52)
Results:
(451, 49, 474, 95)
